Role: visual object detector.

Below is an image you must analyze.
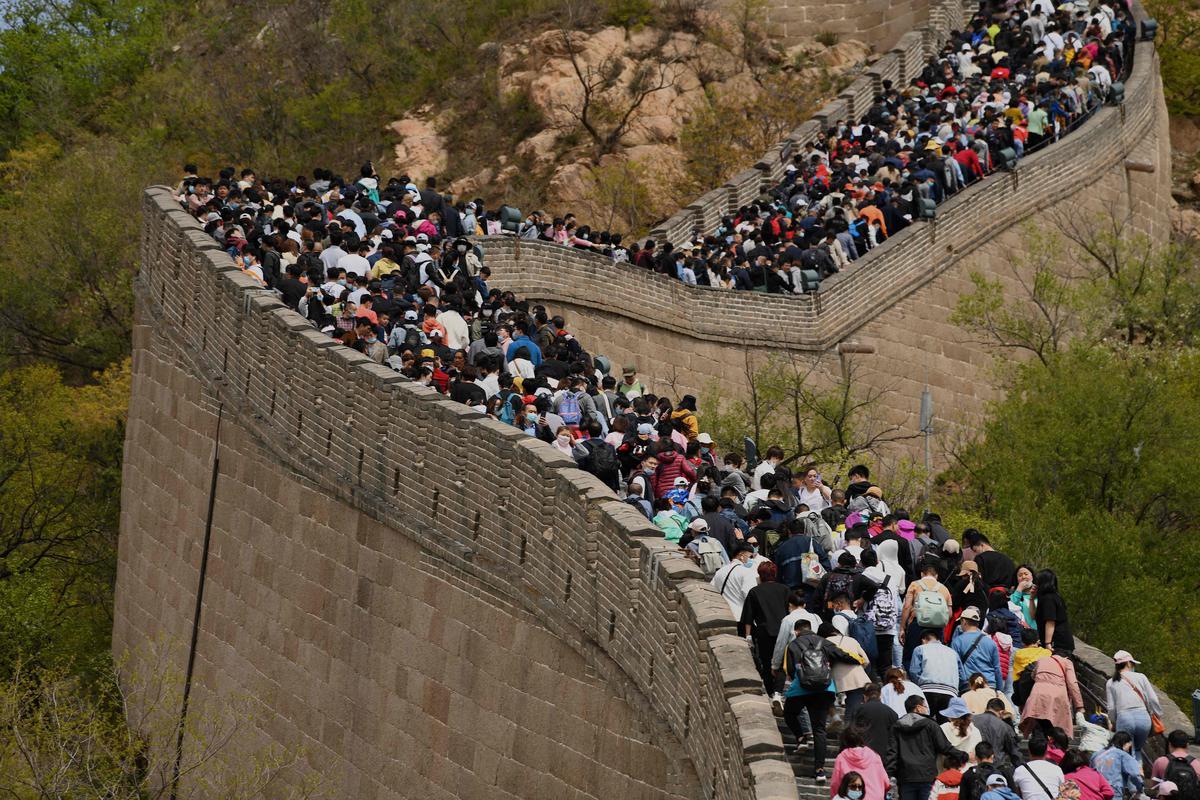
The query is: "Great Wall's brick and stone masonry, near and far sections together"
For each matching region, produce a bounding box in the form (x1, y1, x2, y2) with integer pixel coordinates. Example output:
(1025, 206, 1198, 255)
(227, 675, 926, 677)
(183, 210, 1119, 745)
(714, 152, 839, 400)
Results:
(114, 2, 1186, 800)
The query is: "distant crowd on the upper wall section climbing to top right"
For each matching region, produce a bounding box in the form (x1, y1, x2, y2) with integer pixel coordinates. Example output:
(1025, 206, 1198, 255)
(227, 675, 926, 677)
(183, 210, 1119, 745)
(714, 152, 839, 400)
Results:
(504, 0, 1136, 294)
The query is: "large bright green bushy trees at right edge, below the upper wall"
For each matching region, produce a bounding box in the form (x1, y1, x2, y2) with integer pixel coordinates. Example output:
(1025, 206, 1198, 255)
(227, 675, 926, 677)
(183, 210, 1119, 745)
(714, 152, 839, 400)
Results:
(944, 217, 1200, 698)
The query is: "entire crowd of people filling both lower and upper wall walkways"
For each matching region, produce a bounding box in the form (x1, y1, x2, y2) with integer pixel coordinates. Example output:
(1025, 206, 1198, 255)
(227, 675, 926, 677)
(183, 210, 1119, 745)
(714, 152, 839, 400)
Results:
(178, 0, 1176, 800)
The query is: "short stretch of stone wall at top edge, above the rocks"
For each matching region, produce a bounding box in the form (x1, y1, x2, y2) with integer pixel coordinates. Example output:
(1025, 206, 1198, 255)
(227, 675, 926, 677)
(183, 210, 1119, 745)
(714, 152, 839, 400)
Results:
(767, 0, 930, 49)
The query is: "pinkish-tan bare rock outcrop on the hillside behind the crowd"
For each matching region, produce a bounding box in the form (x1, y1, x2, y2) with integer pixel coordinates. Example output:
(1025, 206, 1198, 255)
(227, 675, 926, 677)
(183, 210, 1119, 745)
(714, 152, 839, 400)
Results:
(391, 17, 871, 225)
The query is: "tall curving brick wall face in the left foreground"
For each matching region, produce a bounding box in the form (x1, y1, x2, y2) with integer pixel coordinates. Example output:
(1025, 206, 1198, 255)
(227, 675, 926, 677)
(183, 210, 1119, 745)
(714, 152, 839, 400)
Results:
(113, 188, 796, 800)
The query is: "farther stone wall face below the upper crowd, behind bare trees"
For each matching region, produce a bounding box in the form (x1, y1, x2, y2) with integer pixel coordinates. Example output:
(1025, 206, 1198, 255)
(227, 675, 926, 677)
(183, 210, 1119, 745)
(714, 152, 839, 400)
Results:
(484, 26, 1170, 457)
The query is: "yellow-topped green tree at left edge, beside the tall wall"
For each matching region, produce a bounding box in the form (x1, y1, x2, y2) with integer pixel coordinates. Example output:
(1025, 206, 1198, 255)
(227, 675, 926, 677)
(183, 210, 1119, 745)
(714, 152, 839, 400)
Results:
(0, 361, 130, 679)
